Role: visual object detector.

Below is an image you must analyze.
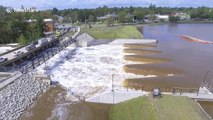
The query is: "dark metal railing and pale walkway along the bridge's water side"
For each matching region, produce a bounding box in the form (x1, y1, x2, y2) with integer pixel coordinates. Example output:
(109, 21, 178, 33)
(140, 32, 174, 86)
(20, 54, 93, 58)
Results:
(0, 36, 77, 89)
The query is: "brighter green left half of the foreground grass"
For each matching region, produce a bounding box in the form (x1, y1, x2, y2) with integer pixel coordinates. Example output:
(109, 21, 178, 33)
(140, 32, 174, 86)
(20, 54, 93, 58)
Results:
(109, 97, 158, 120)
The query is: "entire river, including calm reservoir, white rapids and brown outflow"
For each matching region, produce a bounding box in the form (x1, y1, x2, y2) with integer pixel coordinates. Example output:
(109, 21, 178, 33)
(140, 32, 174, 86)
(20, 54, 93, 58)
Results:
(21, 24, 213, 120)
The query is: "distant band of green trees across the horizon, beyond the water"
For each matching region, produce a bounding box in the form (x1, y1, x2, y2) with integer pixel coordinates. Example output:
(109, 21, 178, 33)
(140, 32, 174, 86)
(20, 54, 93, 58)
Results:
(57, 5, 213, 23)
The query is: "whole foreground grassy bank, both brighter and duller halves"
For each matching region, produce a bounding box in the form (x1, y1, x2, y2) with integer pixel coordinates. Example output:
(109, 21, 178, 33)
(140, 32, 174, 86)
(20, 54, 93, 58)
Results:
(109, 95, 208, 120)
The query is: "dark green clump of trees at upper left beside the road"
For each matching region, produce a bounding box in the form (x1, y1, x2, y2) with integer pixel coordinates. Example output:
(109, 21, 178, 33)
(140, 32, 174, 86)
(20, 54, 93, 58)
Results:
(0, 6, 52, 44)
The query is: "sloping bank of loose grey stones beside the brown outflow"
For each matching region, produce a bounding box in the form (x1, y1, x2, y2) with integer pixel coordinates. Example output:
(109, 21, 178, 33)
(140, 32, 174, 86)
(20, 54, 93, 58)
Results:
(0, 72, 49, 120)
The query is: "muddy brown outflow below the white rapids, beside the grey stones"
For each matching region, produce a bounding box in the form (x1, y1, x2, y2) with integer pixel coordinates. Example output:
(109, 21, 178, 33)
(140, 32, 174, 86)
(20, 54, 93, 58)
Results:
(20, 86, 111, 120)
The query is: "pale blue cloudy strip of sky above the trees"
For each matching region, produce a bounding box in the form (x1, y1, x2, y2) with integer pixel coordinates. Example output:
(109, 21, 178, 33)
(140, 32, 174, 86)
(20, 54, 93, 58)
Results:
(0, 0, 213, 10)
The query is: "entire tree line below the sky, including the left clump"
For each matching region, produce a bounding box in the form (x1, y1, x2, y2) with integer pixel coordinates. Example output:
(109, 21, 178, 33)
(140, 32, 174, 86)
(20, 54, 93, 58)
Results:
(0, 4, 213, 44)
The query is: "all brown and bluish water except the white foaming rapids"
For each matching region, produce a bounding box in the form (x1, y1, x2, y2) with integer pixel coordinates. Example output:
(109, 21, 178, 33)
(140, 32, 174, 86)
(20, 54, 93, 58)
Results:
(20, 24, 213, 120)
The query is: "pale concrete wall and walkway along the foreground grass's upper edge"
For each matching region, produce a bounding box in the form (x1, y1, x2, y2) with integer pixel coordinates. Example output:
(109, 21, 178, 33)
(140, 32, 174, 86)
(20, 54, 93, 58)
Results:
(86, 87, 213, 104)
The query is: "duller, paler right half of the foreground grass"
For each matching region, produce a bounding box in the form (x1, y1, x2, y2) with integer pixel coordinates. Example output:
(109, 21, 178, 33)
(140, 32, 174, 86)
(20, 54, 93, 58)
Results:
(155, 95, 208, 120)
